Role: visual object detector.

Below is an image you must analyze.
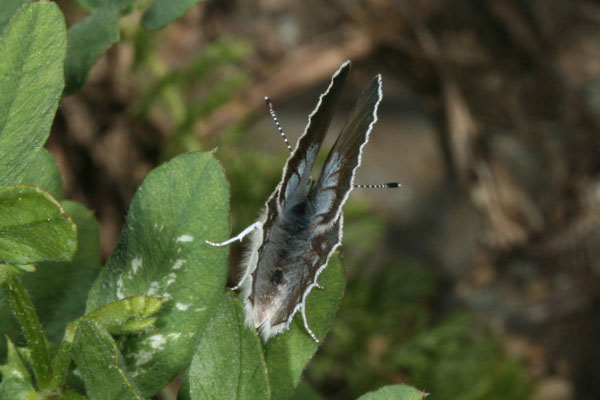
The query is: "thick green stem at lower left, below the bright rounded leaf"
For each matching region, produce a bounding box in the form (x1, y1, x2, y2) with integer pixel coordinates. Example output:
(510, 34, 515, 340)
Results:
(2, 276, 50, 389)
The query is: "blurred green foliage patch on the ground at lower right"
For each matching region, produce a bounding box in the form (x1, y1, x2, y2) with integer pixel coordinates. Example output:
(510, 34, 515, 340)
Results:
(308, 264, 531, 400)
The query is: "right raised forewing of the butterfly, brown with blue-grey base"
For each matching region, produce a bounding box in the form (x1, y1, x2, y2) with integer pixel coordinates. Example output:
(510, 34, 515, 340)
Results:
(310, 75, 383, 229)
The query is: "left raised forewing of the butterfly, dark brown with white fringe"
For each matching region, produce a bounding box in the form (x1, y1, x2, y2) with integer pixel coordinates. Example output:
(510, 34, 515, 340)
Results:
(277, 61, 350, 208)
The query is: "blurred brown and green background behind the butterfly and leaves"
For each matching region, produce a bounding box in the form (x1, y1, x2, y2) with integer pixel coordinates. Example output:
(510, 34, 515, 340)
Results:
(48, 0, 600, 400)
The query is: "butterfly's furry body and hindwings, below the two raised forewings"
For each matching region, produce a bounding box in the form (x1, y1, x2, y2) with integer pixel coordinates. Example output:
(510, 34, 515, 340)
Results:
(242, 183, 341, 339)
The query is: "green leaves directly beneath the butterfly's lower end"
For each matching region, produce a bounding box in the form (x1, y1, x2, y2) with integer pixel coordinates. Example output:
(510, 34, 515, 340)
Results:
(179, 256, 345, 399)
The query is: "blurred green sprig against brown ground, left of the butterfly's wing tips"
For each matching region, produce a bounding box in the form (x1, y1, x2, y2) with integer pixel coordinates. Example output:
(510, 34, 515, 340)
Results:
(130, 35, 248, 159)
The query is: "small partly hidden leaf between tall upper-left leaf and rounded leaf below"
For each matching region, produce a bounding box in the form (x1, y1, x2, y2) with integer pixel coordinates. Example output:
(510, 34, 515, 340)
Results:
(15, 148, 62, 200)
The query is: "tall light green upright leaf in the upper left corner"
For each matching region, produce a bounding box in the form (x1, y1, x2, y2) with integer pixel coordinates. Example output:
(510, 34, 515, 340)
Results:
(0, 2, 67, 187)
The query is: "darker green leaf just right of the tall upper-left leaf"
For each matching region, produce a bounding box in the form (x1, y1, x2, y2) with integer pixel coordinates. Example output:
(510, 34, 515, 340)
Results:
(65, 6, 120, 95)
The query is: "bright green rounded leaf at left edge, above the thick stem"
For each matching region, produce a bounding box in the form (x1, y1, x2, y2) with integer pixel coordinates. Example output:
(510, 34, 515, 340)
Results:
(0, 186, 77, 264)
